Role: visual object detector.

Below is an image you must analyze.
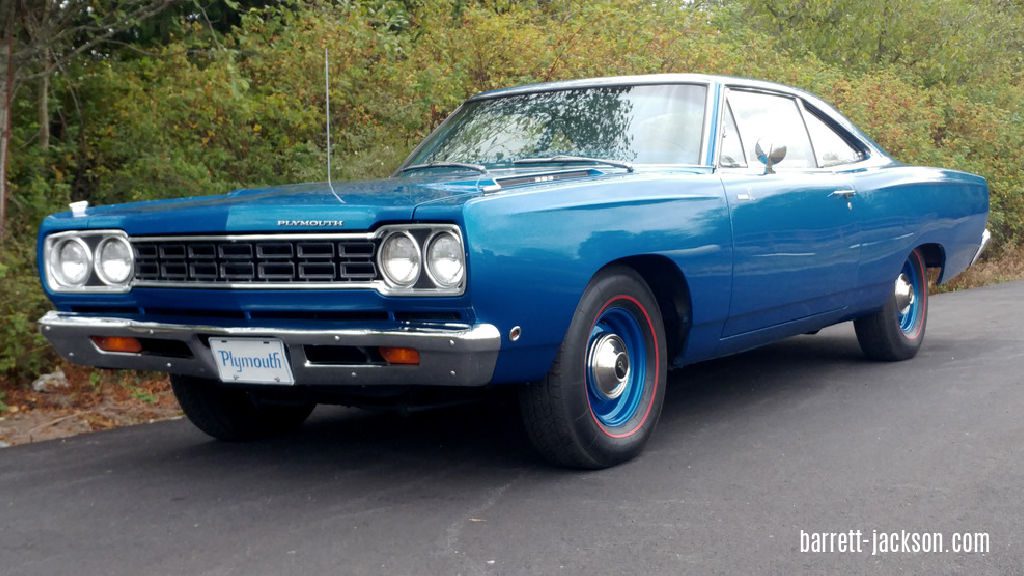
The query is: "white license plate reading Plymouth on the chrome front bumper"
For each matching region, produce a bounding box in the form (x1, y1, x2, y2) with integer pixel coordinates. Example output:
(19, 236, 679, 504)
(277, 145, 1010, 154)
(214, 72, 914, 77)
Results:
(210, 338, 295, 384)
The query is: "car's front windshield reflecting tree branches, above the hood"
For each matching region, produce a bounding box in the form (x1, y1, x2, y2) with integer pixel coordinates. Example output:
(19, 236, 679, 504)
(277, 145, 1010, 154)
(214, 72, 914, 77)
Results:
(406, 84, 707, 168)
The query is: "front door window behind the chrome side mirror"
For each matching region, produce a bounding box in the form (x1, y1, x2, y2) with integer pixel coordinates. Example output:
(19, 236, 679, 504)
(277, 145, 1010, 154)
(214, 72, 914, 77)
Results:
(729, 90, 817, 170)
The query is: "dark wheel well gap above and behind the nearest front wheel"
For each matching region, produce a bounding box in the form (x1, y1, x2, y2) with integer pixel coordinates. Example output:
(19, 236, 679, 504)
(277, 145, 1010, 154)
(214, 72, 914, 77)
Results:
(608, 254, 692, 361)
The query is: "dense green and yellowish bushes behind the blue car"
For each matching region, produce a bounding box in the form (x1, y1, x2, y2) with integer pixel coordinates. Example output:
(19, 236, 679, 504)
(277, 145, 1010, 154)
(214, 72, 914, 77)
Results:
(0, 0, 1024, 382)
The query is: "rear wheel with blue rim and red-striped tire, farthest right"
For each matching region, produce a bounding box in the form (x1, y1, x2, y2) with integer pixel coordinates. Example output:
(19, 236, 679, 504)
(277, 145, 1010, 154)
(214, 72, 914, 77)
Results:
(853, 250, 928, 362)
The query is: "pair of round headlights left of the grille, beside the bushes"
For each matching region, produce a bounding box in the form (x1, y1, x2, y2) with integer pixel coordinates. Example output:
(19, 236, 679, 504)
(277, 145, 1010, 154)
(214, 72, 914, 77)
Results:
(43, 230, 135, 292)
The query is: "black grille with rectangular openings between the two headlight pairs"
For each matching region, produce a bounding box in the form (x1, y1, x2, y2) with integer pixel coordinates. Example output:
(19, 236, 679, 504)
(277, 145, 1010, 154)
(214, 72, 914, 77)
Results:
(131, 236, 380, 285)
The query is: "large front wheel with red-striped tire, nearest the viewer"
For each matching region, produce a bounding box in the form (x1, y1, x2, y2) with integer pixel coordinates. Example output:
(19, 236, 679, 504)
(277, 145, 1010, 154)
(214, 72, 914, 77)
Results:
(520, 266, 668, 468)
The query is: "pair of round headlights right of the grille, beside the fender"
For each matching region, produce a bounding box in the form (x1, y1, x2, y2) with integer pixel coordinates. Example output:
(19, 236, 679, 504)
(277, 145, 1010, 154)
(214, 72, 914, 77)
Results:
(377, 224, 466, 295)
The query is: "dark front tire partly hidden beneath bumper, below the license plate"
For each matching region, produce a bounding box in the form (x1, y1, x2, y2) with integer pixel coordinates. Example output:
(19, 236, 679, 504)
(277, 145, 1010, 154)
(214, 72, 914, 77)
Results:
(171, 374, 316, 442)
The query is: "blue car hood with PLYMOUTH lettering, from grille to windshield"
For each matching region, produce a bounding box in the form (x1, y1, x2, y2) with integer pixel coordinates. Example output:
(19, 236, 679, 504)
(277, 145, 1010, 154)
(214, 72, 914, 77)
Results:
(41, 168, 712, 236)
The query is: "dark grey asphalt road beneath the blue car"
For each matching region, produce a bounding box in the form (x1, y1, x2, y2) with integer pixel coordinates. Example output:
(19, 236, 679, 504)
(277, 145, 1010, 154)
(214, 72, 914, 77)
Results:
(0, 283, 1024, 576)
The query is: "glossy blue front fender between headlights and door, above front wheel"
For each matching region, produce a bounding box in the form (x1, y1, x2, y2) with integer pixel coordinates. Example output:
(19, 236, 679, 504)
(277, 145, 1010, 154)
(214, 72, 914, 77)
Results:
(454, 173, 732, 382)
